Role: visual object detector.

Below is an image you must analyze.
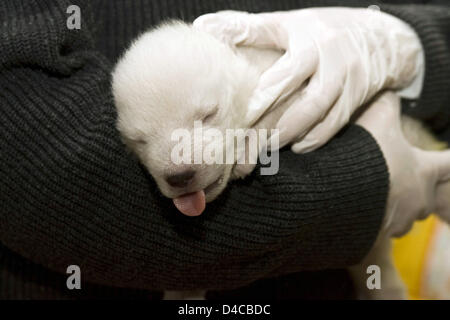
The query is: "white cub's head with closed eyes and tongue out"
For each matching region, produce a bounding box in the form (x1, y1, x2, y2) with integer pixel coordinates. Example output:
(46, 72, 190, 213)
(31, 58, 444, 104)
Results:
(112, 22, 253, 215)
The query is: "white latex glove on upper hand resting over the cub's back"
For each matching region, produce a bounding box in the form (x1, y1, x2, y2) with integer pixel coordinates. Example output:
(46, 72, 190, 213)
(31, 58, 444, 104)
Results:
(194, 7, 423, 152)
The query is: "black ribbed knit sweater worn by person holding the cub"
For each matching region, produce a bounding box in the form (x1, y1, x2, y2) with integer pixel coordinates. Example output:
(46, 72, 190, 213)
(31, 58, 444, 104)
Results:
(0, 0, 450, 298)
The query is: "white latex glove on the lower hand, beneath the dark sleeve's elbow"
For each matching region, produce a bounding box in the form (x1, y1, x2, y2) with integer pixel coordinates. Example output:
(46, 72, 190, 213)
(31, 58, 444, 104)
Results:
(356, 92, 450, 236)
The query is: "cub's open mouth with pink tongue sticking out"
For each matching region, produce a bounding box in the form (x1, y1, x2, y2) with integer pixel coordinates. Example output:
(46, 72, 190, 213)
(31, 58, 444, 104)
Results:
(173, 175, 223, 217)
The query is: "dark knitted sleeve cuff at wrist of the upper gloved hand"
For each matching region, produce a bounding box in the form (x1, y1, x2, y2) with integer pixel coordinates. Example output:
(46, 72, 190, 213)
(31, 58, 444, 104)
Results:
(381, 1, 450, 138)
